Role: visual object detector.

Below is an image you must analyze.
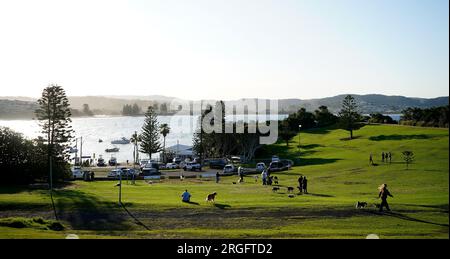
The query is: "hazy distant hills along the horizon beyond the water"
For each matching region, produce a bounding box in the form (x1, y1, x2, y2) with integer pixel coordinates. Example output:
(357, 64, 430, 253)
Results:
(0, 94, 449, 119)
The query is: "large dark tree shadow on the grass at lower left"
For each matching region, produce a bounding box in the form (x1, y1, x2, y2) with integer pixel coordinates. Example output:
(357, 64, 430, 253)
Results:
(53, 190, 131, 230)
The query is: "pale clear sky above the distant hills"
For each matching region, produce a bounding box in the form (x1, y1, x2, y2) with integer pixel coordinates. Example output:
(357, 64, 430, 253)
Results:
(0, 0, 449, 100)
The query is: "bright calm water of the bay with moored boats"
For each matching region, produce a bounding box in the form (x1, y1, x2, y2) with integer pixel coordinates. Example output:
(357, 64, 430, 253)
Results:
(0, 115, 287, 161)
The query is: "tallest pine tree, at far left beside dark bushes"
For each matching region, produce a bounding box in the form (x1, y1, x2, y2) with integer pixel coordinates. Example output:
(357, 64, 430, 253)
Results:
(35, 85, 73, 186)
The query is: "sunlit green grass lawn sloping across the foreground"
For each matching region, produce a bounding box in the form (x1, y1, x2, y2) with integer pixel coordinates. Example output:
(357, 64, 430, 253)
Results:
(0, 125, 449, 241)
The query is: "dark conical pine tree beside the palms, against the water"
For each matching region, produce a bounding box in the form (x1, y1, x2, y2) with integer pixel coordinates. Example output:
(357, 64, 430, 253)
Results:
(140, 106, 161, 159)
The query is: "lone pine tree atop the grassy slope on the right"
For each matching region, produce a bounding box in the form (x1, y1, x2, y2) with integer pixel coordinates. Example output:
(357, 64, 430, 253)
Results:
(339, 95, 362, 139)
